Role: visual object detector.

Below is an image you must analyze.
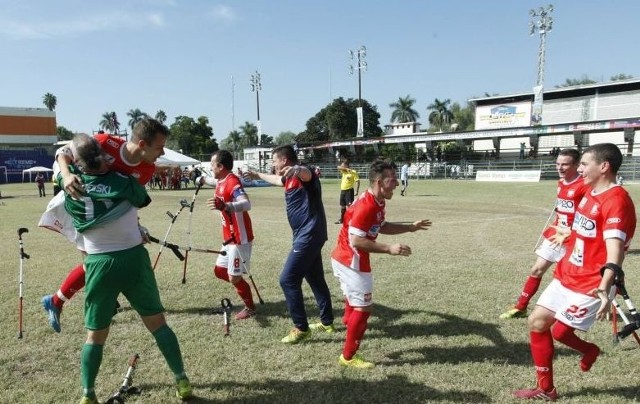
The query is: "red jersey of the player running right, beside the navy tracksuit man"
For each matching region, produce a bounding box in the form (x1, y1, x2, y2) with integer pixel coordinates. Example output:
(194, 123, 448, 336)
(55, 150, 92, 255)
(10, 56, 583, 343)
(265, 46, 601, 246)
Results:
(331, 191, 385, 272)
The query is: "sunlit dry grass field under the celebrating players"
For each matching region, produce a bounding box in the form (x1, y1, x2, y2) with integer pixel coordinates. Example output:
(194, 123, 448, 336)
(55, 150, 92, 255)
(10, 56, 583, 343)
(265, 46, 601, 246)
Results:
(0, 180, 640, 403)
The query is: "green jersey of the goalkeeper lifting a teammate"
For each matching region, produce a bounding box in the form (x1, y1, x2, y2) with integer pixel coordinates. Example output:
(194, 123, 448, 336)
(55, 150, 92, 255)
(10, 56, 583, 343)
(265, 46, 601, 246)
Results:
(56, 166, 151, 233)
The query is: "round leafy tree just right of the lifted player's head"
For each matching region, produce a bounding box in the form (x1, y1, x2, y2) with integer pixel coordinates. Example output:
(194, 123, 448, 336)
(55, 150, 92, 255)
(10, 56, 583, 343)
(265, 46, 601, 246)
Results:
(167, 116, 218, 155)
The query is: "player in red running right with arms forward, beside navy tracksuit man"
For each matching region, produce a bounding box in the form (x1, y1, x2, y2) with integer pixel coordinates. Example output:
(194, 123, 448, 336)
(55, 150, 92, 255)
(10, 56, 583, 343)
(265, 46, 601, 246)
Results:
(331, 160, 431, 369)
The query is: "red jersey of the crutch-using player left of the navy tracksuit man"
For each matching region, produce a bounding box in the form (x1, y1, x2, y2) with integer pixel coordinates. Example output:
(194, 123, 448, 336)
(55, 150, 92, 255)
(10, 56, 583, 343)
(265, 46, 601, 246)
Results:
(215, 173, 253, 244)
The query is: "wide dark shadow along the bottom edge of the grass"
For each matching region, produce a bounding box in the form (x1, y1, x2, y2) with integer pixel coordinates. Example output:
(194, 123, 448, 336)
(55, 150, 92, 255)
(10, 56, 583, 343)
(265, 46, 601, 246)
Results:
(140, 369, 491, 404)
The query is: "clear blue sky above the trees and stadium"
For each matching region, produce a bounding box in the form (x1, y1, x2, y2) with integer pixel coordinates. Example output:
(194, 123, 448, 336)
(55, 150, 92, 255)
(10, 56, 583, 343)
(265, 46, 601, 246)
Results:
(0, 0, 640, 141)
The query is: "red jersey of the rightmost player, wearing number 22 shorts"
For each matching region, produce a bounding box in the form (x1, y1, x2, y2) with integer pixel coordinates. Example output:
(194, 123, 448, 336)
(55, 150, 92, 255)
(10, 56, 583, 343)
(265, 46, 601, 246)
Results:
(554, 185, 636, 294)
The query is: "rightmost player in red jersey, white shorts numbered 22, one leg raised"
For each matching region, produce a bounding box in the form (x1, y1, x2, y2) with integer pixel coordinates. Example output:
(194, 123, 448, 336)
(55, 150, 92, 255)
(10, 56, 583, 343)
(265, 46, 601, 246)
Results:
(513, 143, 636, 400)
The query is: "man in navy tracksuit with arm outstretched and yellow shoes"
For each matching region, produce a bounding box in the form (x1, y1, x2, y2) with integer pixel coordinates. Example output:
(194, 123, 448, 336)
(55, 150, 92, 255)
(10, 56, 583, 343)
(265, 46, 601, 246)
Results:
(244, 145, 335, 344)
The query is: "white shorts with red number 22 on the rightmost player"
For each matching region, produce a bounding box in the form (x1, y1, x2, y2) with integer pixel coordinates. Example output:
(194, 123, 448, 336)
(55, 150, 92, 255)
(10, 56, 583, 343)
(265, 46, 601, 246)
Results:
(536, 279, 601, 331)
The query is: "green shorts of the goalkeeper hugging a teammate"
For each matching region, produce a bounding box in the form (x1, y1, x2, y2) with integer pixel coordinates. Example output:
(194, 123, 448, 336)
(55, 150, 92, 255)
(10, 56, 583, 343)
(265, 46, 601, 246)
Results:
(84, 244, 164, 330)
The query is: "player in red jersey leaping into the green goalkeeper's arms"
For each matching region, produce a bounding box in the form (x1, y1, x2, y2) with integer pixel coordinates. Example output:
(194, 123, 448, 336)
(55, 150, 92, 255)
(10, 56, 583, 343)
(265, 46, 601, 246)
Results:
(39, 118, 169, 332)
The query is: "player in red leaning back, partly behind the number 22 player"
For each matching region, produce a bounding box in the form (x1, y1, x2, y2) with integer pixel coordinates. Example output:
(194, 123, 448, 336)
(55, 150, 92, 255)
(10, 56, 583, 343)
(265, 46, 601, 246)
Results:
(500, 149, 589, 319)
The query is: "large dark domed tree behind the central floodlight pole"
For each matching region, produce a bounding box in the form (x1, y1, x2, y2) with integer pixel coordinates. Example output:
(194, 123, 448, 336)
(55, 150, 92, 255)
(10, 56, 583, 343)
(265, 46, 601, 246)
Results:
(296, 97, 382, 142)
